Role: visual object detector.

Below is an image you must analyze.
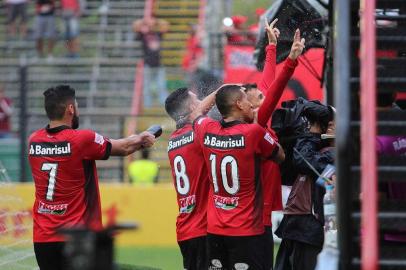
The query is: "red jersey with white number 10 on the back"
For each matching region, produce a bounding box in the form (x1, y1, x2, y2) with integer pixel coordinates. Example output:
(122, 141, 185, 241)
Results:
(193, 118, 279, 236)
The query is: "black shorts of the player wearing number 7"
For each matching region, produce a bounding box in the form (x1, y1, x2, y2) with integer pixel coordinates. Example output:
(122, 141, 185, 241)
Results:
(34, 242, 67, 270)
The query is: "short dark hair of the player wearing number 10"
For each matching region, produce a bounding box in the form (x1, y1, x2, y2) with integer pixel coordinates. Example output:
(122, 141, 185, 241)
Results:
(216, 85, 242, 117)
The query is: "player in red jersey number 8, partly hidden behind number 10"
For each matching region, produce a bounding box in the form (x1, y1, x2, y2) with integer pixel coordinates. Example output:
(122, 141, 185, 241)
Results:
(165, 88, 216, 270)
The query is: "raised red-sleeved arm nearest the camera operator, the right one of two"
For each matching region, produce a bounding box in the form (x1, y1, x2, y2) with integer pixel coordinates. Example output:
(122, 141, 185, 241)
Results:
(258, 29, 305, 126)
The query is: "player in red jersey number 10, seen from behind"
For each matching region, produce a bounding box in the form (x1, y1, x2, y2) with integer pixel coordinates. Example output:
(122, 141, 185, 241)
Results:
(193, 85, 284, 270)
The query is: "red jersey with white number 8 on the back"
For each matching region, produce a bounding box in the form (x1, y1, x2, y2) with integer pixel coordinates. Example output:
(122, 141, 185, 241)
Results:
(168, 124, 210, 241)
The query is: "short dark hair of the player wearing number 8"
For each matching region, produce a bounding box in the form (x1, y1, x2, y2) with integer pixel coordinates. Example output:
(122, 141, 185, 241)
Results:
(165, 87, 190, 122)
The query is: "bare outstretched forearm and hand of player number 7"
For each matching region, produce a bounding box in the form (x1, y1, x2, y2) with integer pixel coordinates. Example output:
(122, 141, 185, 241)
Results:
(110, 131, 155, 156)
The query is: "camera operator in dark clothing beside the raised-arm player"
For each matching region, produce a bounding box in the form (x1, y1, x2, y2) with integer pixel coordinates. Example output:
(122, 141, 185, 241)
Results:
(275, 101, 335, 270)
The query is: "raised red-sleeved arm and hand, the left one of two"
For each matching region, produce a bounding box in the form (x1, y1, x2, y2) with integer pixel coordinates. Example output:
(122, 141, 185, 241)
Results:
(258, 18, 280, 95)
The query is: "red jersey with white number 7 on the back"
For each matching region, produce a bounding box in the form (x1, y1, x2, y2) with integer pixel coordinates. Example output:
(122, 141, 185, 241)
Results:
(28, 126, 111, 242)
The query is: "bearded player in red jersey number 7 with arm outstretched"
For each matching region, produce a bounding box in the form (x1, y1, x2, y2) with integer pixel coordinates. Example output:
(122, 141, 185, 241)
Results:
(28, 85, 155, 270)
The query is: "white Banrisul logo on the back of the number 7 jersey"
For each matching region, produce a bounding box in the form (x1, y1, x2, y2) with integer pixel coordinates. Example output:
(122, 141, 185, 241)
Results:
(30, 142, 72, 157)
